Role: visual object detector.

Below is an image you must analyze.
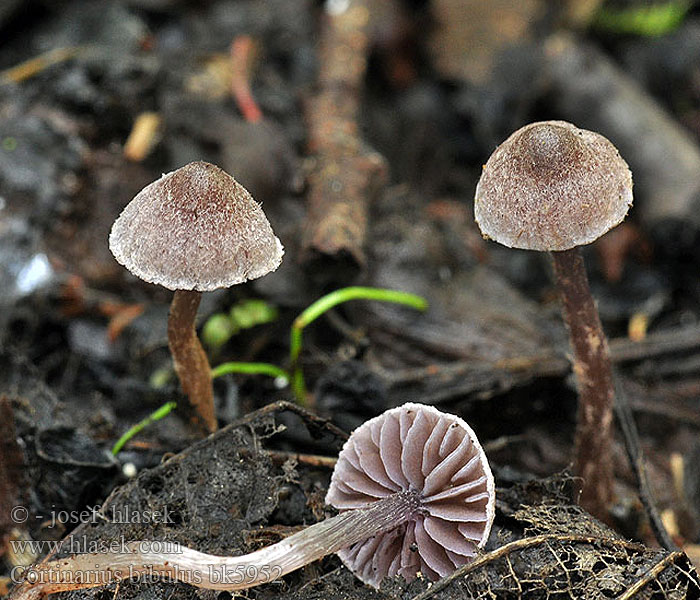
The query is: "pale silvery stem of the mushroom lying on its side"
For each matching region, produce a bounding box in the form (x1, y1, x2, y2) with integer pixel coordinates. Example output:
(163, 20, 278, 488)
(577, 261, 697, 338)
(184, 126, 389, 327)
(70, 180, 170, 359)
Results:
(13, 491, 420, 600)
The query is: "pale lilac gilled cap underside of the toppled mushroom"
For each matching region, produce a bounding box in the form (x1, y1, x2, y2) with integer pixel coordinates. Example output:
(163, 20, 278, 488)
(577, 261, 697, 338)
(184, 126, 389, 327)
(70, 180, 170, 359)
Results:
(326, 404, 495, 587)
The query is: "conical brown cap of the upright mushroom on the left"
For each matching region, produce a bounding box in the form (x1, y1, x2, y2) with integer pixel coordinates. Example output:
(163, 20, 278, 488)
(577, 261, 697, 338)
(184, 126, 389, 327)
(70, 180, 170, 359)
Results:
(109, 162, 284, 291)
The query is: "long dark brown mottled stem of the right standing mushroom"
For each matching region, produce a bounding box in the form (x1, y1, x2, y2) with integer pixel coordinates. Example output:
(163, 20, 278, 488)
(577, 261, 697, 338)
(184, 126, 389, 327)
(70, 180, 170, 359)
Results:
(552, 248, 615, 517)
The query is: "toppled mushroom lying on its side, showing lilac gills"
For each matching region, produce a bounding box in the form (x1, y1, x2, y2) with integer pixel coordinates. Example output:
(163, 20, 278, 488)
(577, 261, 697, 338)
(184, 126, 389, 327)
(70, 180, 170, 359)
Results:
(14, 404, 495, 600)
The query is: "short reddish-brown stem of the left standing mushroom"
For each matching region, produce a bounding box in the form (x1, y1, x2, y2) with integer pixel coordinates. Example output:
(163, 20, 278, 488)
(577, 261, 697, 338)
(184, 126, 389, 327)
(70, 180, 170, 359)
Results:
(168, 290, 216, 432)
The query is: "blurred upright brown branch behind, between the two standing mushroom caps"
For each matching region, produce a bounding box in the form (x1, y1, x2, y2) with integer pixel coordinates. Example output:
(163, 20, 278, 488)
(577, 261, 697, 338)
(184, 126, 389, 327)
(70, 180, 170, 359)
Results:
(302, 0, 387, 280)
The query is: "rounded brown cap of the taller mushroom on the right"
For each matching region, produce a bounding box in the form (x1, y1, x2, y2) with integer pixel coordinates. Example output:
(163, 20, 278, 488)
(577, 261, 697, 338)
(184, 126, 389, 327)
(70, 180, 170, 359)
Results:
(474, 121, 632, 251)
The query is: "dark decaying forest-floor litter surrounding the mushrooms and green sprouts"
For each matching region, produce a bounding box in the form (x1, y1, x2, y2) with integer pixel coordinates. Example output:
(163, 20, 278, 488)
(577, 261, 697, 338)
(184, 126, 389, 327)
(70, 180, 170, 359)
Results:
(0, 0, 700, 600)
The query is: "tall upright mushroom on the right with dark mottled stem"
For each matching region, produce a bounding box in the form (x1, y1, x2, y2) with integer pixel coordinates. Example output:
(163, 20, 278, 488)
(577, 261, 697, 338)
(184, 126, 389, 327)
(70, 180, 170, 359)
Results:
(474, 121, 632, 517)
